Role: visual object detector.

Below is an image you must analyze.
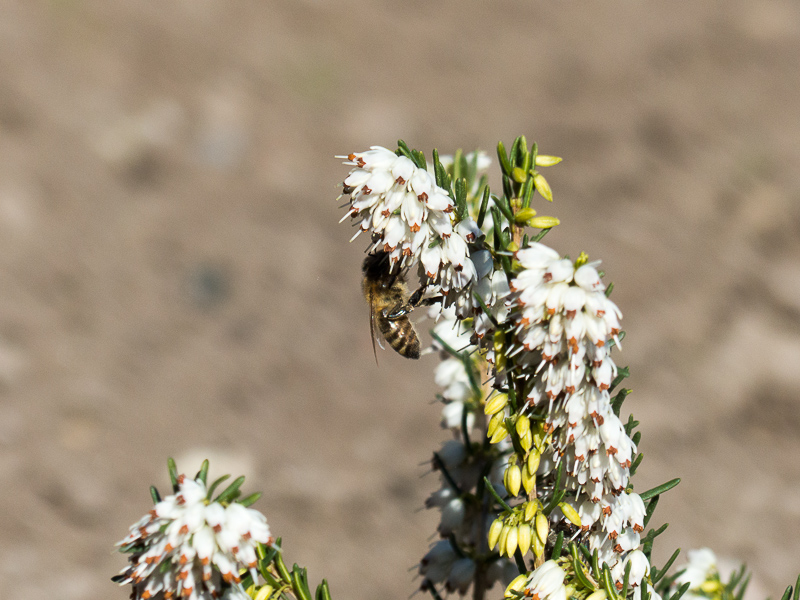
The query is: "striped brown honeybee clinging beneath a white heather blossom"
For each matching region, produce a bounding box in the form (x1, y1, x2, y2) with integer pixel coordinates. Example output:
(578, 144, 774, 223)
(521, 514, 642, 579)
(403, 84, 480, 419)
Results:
(361, 251, 424, 360)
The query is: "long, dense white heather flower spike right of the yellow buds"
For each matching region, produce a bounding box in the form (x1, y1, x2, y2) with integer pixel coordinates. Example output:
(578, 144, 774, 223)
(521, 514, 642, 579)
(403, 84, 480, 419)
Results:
(508, 243, 645, 575)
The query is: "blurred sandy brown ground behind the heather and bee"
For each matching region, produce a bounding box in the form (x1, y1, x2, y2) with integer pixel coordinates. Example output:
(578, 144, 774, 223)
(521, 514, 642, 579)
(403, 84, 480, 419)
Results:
(0, 0, 800, 600)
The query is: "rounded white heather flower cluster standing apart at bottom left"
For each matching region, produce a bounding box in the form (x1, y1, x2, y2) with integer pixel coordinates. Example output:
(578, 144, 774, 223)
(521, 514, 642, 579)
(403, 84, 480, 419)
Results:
(117, 475, 272, 600)
